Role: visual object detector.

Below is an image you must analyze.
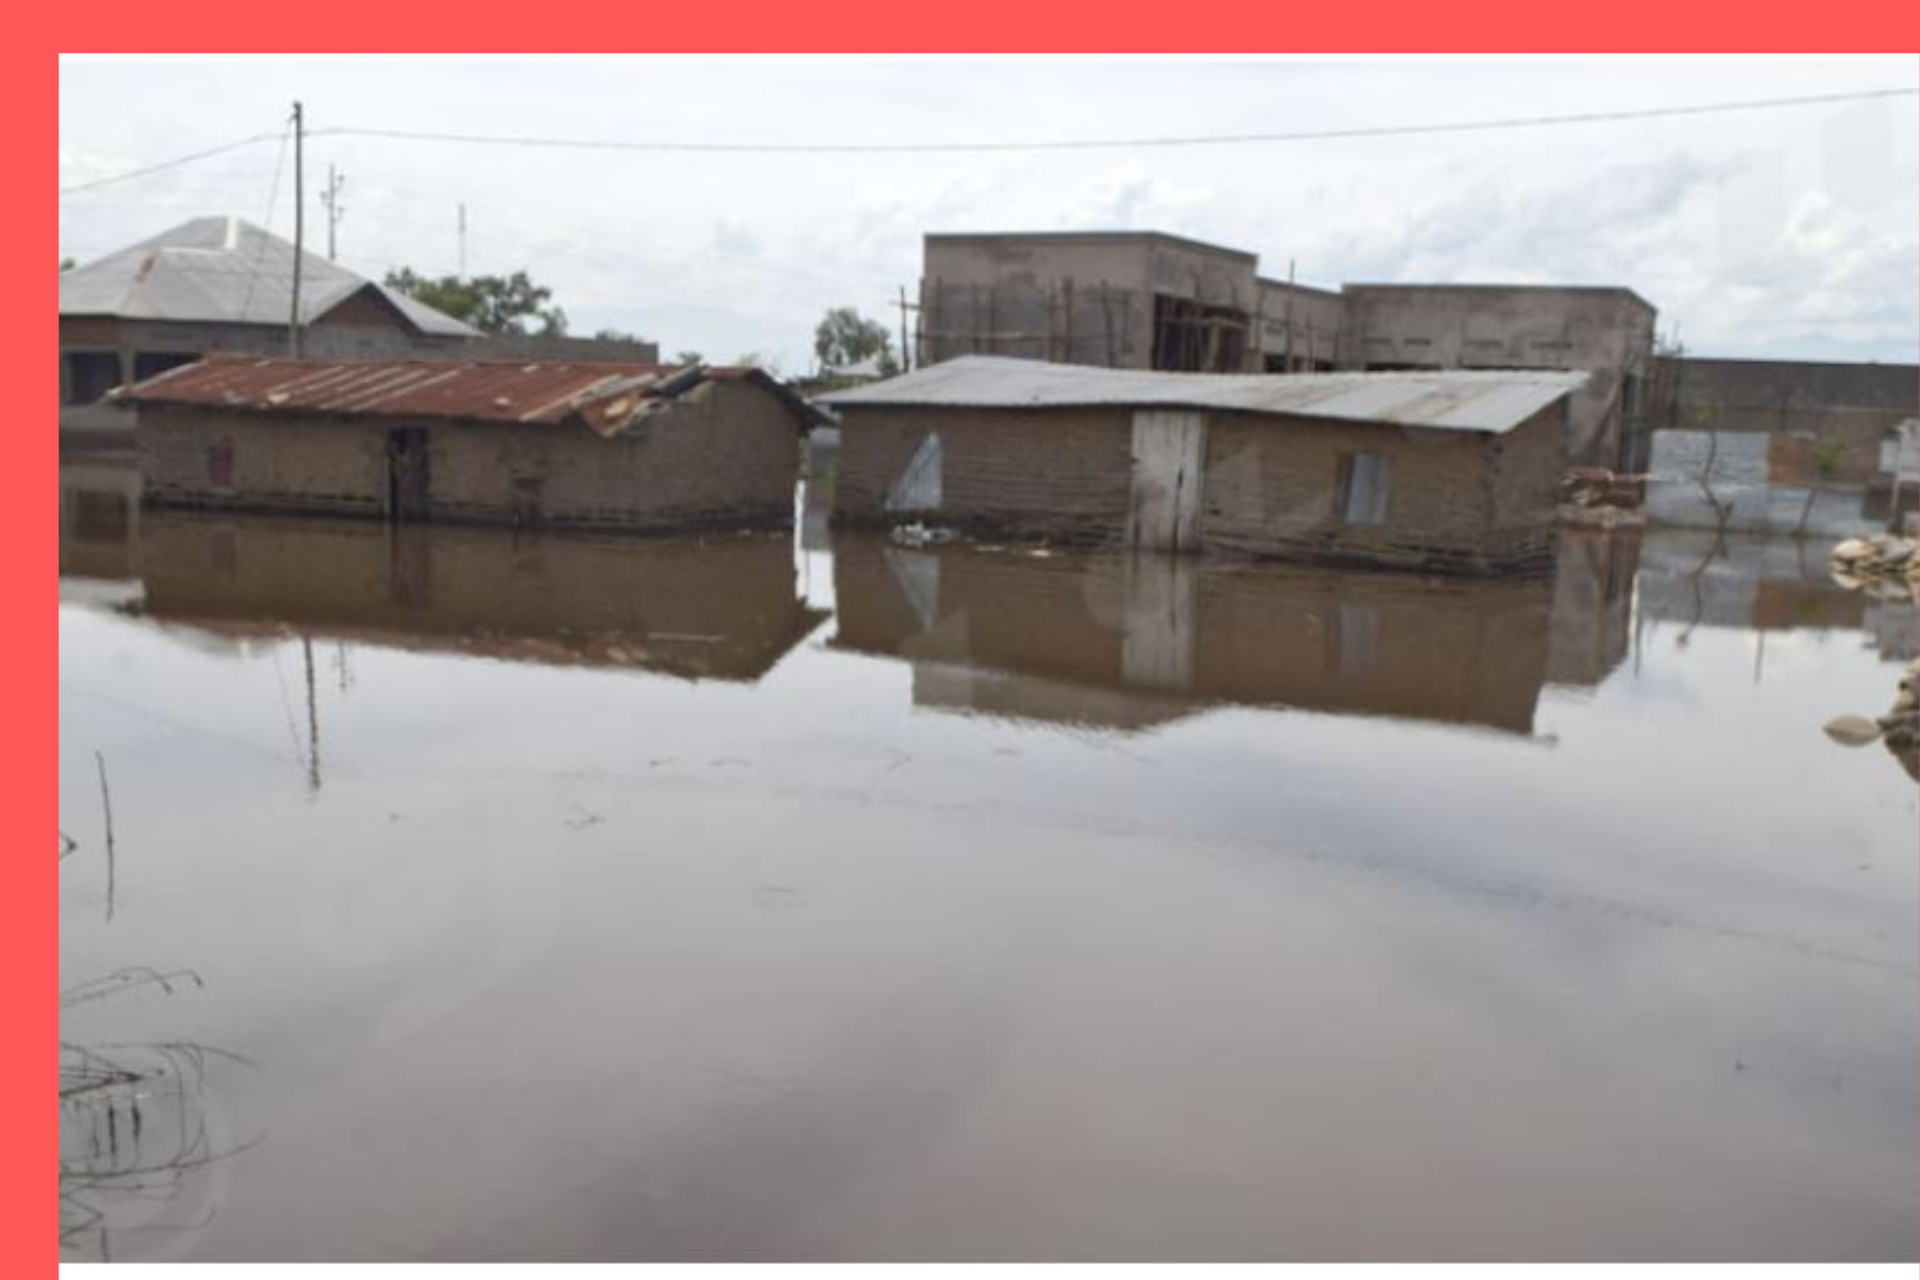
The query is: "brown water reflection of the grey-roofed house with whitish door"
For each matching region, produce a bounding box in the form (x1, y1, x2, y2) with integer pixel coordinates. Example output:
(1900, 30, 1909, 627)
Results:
(833, 529, 1632, 733)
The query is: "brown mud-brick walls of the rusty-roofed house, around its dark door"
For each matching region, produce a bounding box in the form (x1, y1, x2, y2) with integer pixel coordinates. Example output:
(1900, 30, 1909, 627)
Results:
(138, 382, 801, 530)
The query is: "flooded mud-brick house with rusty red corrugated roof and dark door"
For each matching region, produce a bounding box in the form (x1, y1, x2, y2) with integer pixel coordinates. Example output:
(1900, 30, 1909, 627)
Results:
(119, 357, 818, 532)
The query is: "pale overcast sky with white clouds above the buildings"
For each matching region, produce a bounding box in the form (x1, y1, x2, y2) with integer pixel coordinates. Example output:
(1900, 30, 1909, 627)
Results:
(60, 59, 1920, 372)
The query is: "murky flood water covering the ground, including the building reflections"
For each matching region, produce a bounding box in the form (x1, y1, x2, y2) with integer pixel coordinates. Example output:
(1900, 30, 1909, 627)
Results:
(60, 464, 1920, 1261)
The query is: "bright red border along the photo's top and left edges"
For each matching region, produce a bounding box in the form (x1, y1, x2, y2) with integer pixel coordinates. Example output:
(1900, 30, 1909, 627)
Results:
(37, 35, 1920, 1263)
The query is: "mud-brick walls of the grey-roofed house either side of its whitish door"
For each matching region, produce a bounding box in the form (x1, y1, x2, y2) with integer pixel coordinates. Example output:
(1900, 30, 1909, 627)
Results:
(833, 405, 1565, 572)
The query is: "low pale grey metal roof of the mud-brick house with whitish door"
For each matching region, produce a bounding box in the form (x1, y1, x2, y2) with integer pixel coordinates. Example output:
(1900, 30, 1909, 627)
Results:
(822, 355, 1590, 434)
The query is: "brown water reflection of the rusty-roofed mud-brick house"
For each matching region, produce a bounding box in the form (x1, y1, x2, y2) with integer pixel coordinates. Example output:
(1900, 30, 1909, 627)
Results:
(108, 510, 824, 679)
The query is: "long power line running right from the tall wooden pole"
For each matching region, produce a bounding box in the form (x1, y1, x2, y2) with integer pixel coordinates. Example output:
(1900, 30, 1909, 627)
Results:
(313, 86, 1920, 155)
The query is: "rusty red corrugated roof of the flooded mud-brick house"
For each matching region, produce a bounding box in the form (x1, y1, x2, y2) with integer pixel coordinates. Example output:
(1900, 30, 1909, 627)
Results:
(115, 355, 820, 436)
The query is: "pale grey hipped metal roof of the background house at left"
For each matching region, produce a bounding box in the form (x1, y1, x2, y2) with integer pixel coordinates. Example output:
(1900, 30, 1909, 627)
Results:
(60, 217, 478, 338)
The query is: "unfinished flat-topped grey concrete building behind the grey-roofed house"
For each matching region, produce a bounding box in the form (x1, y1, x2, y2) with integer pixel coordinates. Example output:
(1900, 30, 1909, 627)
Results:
(918, 232, 1655, 470)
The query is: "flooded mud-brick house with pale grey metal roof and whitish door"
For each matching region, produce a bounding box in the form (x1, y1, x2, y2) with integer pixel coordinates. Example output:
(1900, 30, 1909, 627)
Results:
(824, 357, 1586, 572)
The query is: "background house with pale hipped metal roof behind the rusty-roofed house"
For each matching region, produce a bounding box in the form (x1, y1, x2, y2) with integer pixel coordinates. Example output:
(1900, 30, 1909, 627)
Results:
(60, 217, 480, 405)
